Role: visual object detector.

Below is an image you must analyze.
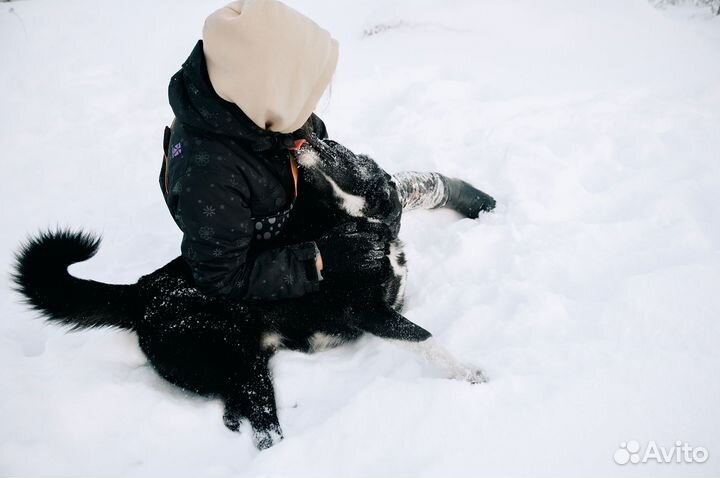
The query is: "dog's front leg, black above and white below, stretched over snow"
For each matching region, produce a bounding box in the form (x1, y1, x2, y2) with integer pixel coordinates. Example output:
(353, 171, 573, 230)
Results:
(361, 308, 488, 383)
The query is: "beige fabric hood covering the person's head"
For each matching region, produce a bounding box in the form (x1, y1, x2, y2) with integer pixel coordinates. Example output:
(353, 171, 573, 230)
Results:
(203, 0, 338, 133)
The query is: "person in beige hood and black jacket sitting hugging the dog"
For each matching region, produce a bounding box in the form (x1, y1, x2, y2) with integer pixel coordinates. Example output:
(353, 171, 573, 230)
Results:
(160, 0, 494, 299)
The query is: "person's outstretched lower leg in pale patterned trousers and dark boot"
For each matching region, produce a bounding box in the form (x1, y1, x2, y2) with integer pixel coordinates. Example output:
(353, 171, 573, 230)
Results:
(393, 171, 495, 219)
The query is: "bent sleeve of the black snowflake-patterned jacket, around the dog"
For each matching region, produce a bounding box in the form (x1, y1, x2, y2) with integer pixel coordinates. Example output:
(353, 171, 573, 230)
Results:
(172, 145, 320, 300)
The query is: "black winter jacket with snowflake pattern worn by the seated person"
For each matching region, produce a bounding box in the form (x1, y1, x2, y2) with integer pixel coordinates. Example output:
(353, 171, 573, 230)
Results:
(160, 41, 327, 299)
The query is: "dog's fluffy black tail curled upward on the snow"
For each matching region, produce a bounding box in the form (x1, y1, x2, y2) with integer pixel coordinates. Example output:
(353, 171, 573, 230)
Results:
(12, 230, 142, 330)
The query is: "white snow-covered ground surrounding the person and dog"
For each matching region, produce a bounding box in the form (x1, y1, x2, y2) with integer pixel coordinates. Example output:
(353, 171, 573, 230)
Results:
(0, 0, 720, 476)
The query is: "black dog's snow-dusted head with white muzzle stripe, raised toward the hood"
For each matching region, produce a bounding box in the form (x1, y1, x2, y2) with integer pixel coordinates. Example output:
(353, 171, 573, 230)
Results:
(297, 135, 402, 235)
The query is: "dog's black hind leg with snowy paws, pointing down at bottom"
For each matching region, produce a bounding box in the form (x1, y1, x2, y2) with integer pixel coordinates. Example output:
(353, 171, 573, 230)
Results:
(223, 354, 283, 450)
